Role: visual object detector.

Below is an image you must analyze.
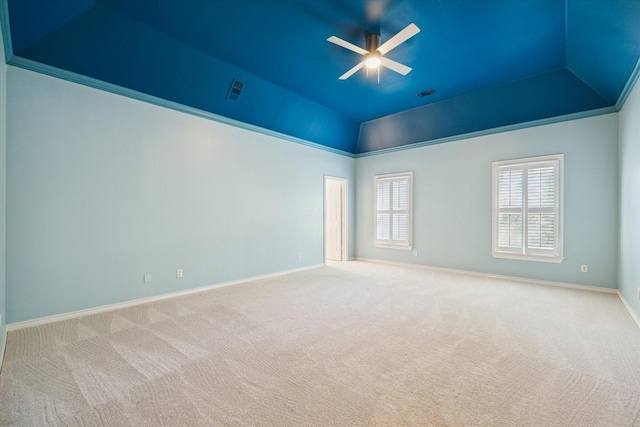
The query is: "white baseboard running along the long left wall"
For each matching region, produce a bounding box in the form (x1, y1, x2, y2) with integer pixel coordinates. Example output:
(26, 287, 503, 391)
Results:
(6, 264, 324, 332)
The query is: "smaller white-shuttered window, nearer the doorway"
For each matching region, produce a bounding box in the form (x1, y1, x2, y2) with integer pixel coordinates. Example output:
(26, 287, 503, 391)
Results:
(374, 172, 413, 250)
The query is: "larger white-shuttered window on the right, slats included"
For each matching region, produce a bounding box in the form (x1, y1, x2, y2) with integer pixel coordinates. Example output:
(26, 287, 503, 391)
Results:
(492, 154, 564, 263)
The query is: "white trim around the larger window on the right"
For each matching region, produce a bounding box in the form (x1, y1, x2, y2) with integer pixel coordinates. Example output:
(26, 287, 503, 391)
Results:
(491, 154, 564, 263)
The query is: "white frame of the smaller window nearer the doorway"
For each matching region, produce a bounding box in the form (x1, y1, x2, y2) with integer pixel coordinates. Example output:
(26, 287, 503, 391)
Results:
(373, 171, 413, 251)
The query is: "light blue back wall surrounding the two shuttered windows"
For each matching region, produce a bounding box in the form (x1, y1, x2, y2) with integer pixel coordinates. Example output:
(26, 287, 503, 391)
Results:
(356, 114, 618, 288)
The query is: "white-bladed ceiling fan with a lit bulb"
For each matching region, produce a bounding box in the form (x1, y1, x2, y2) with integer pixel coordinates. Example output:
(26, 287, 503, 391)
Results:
(327, 23, 420, 82)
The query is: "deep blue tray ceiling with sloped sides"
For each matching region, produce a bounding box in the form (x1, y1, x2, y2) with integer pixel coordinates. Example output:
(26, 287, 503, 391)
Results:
(2, 0, 640, 154)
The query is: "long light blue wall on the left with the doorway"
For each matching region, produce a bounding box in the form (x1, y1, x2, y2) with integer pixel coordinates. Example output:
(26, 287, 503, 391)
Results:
(7, 66, 355, 322)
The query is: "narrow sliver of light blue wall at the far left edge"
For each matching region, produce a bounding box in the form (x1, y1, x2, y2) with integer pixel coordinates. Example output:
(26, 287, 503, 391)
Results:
(0, 6, 7, 352)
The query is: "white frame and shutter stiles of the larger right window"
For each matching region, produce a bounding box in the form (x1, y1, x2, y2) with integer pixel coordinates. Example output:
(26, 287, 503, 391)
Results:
(491, 154, 564, 263)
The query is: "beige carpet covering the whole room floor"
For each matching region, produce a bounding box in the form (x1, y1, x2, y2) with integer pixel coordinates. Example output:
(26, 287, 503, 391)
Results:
(0, 262, 640, 427)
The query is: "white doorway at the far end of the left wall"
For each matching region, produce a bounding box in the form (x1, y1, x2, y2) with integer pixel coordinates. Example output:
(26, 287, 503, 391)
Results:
(324, 176, 348, 261)
